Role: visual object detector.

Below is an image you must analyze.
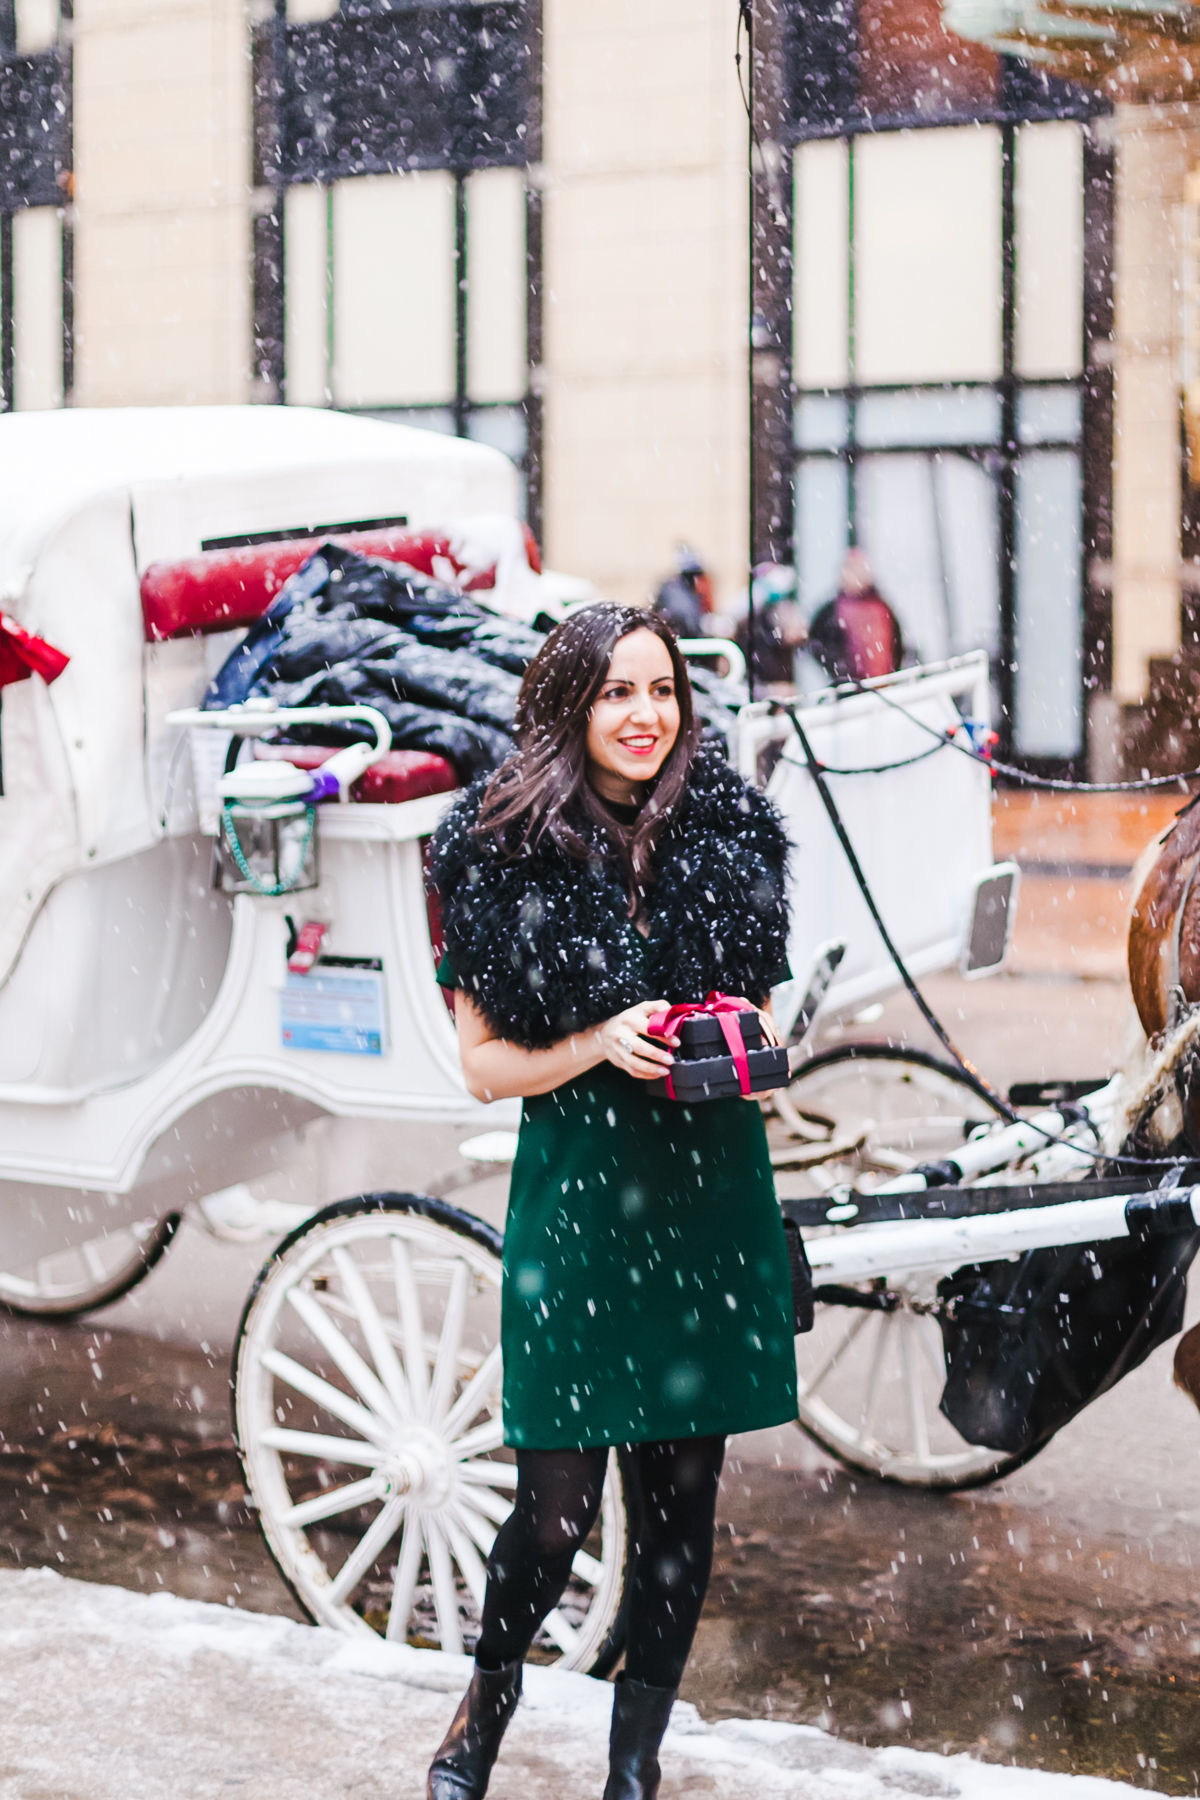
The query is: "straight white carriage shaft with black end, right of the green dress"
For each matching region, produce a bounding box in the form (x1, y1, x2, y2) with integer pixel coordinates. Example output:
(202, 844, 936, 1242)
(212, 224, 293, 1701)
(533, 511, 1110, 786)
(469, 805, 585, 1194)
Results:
(804, 1188, 1200, 1283)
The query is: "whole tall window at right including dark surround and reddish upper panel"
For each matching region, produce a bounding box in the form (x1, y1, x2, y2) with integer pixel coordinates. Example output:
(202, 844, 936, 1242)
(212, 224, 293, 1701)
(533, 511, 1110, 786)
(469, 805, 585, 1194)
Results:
(780, 0, 1114, 765)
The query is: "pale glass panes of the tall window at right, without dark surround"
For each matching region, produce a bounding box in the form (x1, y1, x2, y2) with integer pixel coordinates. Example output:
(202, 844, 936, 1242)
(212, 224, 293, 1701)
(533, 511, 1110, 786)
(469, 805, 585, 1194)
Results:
(793, 121, 1083, 760)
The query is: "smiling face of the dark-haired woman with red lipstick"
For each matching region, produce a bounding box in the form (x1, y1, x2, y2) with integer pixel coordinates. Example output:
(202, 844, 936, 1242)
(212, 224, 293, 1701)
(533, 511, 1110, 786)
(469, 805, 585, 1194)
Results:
(587, 632, 680, 805)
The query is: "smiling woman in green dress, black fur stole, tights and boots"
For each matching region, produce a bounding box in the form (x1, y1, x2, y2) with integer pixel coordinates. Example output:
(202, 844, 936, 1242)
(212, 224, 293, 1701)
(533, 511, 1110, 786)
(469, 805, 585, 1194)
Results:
(428, 605, 795, 1800)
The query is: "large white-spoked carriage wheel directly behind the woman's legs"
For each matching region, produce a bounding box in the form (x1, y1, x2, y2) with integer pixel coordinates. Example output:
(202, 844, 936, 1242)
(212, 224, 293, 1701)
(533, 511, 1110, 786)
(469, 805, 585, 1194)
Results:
(234, 1193, 631, 1674)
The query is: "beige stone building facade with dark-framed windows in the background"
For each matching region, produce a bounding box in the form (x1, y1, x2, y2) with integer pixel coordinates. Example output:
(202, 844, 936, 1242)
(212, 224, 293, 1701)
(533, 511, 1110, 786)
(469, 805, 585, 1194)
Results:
(0, 0, 1144, 767)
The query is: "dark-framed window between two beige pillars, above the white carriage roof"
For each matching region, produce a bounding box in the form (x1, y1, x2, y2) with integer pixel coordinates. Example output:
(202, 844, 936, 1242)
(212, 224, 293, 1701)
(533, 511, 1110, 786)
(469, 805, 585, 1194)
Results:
(255, 0, 542, 529)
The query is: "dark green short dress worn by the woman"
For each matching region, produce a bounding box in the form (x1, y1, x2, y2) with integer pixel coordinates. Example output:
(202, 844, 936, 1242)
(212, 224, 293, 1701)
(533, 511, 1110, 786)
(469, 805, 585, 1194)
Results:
(437, 959, 797, 1449)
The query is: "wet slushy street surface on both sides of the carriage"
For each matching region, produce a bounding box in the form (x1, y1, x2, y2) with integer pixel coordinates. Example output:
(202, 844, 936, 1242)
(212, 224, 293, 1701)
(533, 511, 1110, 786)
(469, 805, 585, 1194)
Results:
(0, 799, 1200, 1795)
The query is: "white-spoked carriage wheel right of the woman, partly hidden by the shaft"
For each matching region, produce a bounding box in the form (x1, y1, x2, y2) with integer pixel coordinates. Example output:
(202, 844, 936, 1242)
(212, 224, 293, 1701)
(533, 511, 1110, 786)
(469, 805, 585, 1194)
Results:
(772, 1044, 1025, 1489)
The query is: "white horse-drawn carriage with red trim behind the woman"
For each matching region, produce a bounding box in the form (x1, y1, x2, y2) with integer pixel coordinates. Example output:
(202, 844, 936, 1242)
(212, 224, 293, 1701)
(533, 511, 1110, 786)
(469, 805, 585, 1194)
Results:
(0, 409, 1165, 1672)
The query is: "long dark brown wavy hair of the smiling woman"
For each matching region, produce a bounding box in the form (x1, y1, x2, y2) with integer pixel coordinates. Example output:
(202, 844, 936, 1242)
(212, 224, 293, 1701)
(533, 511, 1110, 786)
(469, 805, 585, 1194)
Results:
(475, 603, 698, 892)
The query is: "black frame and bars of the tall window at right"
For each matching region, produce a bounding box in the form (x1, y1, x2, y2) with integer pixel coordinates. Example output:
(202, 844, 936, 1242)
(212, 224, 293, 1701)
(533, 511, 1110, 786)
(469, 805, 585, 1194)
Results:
(750, 0, 1114, 774)
